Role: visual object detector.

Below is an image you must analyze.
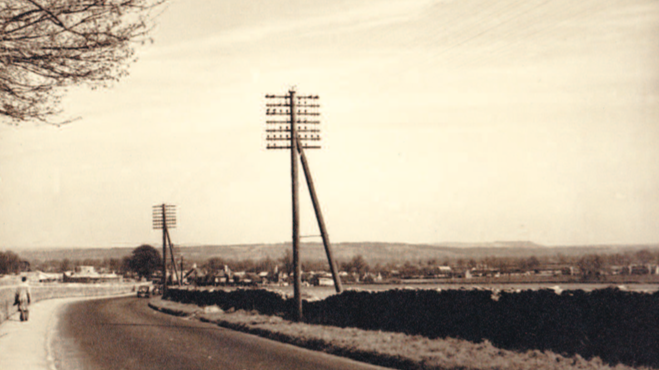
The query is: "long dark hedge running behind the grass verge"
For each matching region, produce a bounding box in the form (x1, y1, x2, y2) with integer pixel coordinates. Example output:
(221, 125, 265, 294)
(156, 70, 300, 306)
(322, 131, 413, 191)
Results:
(166, 288, 659, 367)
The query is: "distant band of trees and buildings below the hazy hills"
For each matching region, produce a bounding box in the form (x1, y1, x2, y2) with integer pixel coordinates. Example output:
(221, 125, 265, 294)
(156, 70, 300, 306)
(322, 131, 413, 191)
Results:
(0, 245, 659, 276)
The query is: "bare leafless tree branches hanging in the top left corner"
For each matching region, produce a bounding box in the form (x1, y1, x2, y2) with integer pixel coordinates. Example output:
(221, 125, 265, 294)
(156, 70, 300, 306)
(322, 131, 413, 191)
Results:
(0, 0, 166, 124)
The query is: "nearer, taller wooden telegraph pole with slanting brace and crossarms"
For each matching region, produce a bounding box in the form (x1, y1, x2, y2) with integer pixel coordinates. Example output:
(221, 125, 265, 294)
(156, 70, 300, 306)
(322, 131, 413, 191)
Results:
(265, 89, 342, 320)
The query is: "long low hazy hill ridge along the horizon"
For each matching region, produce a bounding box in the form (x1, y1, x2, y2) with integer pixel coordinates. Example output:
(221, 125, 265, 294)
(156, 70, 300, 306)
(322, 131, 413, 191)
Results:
(16, 241, 659, 263)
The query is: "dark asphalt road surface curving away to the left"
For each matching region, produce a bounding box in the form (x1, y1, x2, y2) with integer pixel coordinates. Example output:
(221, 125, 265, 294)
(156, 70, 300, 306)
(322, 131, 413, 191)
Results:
(52, 297, 392, 370)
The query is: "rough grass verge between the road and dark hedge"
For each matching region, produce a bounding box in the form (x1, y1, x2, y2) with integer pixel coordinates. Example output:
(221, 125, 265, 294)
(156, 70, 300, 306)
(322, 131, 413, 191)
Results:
(149, 298, 649, 370)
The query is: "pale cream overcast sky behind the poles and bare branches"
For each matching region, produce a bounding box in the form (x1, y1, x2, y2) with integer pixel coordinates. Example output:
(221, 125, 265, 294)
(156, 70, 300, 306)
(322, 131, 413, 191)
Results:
(0, 0, 659, 249)
